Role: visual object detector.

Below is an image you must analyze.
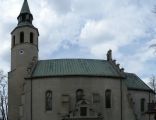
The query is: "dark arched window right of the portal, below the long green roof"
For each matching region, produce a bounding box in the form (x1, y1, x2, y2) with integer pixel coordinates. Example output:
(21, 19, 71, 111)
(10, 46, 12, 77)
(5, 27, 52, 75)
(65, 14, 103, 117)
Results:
(105, 89, 111, 108)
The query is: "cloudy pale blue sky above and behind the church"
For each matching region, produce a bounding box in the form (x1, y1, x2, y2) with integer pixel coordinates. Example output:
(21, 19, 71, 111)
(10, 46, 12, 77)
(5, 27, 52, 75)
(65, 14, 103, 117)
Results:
(0, 0, 156, 82)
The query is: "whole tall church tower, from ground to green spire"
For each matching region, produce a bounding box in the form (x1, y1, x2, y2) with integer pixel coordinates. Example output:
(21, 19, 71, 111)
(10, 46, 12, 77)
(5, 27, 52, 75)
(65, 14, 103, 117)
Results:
(8, 0, 39, 120)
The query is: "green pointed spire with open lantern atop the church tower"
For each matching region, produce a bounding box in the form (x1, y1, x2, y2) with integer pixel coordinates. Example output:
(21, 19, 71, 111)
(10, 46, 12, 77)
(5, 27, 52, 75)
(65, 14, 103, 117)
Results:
(17, 0, 33, 26)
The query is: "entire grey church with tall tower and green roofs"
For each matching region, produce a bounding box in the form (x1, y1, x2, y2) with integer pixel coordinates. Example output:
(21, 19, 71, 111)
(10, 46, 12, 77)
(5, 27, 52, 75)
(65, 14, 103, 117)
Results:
(8, 0, 155, 120)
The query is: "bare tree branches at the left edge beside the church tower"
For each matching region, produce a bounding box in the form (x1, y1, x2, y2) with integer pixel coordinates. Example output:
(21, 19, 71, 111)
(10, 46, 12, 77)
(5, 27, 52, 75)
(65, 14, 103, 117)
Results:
(0, 70, 8, 120)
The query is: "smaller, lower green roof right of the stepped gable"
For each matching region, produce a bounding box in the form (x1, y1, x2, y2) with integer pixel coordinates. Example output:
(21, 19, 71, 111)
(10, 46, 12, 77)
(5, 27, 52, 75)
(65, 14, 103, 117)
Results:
(125, 73, 152, 91)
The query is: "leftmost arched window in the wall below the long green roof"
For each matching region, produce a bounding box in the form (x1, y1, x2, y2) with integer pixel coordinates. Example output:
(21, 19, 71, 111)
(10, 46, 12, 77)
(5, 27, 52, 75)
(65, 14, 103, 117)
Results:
(45, 90, 52, 111)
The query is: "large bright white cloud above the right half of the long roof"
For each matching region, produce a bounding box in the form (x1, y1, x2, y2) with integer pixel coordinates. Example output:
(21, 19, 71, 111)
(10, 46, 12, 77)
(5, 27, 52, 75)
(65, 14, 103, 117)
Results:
(80, 1, 154, 56)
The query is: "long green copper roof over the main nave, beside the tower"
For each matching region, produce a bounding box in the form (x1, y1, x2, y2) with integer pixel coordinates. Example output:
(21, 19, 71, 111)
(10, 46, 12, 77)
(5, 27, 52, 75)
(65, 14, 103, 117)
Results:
(32, 59, 121, 77)
